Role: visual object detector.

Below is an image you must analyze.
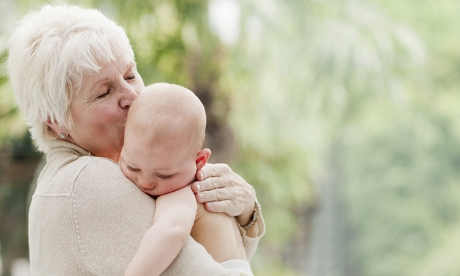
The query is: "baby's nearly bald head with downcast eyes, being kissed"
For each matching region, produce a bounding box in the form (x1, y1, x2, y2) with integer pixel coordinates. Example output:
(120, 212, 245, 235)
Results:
(120, 83, 211, 196)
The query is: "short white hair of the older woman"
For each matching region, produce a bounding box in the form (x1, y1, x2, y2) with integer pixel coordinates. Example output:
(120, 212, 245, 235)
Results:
(7, 5, 134, 153)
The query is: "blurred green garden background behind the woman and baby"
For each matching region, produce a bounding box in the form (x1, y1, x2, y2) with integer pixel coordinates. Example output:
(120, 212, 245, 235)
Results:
(0, 0, 460, 276)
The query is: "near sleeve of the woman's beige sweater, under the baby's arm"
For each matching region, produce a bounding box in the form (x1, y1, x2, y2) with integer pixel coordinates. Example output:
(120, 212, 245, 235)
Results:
(69, 157, 238, 275)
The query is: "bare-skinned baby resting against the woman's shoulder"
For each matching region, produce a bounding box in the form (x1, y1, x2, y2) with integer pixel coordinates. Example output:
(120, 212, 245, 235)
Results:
(120, 83, 252, 275)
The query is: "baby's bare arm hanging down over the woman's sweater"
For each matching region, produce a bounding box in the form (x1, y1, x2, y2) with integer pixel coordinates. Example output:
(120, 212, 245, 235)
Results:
(125, 186, 197, 275)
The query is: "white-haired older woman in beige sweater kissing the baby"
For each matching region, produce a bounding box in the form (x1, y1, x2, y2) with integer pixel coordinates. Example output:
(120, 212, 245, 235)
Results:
(7, 6, 265, 275)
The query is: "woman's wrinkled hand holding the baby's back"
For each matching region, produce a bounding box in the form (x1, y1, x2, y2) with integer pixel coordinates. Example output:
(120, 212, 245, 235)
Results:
(192, 164, 255, 226)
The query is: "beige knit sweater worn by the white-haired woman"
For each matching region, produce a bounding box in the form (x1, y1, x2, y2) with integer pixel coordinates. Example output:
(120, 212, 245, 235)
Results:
(29, 141, 265, 276)
